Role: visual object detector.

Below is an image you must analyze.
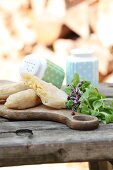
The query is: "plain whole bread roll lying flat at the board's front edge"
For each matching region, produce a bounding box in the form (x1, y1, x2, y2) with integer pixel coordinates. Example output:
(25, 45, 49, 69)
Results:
(5, 89, 41, 109)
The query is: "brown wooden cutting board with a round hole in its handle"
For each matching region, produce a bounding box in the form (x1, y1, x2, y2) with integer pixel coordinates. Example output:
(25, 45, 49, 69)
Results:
(0, 80, 99, 130)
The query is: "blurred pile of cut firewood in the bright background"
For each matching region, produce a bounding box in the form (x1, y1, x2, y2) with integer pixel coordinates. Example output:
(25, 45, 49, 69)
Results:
(0, 0, 113, 82)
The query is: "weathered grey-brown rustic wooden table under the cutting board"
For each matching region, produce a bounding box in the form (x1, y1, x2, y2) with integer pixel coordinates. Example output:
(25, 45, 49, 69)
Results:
(0, 84, 113, 170)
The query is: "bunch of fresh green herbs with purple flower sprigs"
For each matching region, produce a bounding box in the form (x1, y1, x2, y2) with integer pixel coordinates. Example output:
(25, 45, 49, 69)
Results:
(65, 74, 113, 124)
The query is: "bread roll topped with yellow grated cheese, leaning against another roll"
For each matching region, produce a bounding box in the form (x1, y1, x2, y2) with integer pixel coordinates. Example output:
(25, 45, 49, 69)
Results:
(22, 74, 68, 109)
